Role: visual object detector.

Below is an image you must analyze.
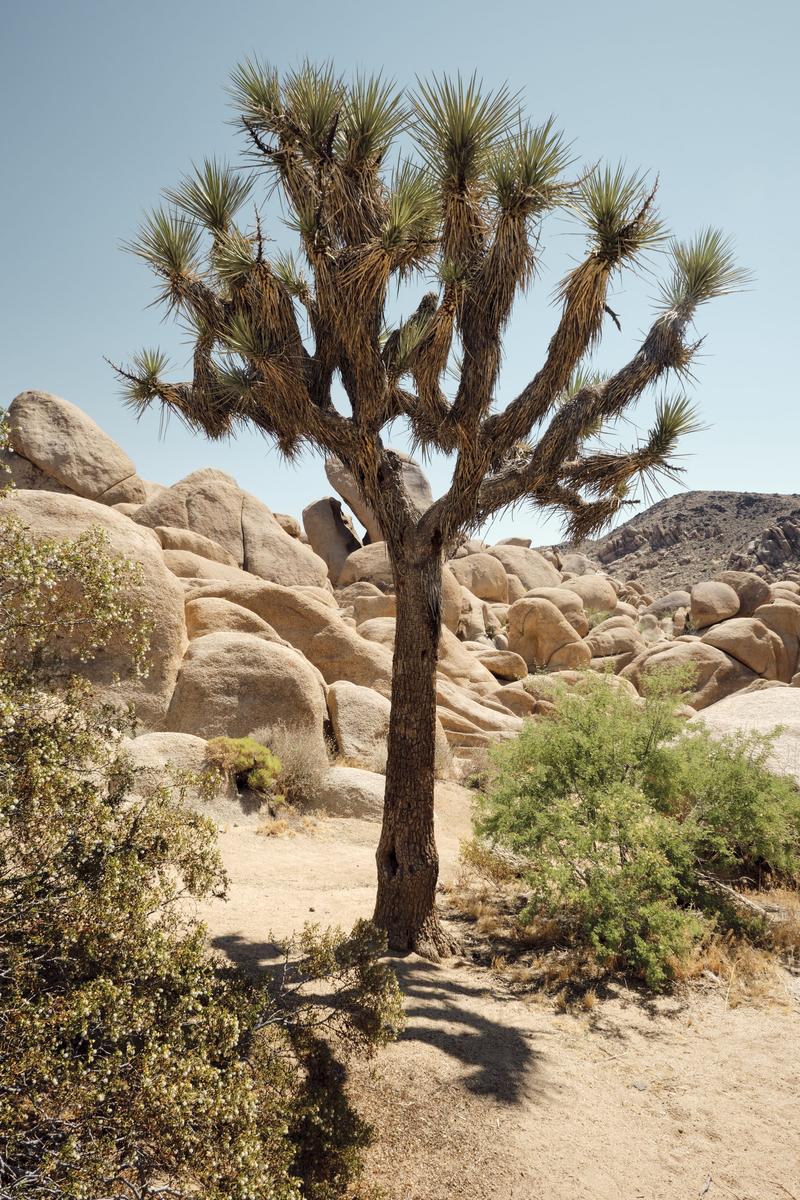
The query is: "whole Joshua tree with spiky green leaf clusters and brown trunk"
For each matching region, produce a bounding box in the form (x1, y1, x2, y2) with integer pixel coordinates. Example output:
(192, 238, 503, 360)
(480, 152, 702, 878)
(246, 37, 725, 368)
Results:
(118, 61, 742, 956)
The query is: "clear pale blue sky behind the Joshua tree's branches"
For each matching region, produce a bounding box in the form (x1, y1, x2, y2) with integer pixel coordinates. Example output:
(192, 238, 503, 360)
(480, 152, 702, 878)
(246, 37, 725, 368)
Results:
(0, 0, 800, 541)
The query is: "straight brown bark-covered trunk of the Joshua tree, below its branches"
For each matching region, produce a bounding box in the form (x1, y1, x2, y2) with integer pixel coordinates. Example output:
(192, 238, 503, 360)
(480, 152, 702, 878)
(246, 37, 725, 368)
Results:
(374, 547, 456, 960)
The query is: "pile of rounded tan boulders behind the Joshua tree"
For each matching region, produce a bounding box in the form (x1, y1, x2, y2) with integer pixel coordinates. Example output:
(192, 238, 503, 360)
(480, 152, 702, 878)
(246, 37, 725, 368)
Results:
(4, 391, 800, 816)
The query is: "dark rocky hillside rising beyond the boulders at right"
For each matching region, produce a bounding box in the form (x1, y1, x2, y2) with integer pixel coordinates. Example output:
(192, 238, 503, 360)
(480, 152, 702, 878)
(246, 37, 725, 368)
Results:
(579, 492, 800, 592)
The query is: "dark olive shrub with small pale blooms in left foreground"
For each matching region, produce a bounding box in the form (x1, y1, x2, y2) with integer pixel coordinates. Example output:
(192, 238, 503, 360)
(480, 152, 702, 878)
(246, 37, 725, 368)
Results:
(0, 508, 399, 1200)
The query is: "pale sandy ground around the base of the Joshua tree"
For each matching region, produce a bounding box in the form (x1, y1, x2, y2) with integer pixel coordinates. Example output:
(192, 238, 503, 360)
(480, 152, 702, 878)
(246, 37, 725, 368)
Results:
(194, 786, 800, 1200)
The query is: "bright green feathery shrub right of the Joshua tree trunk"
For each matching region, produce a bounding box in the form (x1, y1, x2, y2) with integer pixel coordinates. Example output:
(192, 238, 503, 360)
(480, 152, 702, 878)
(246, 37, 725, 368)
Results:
(477, 673, 800, 989)
